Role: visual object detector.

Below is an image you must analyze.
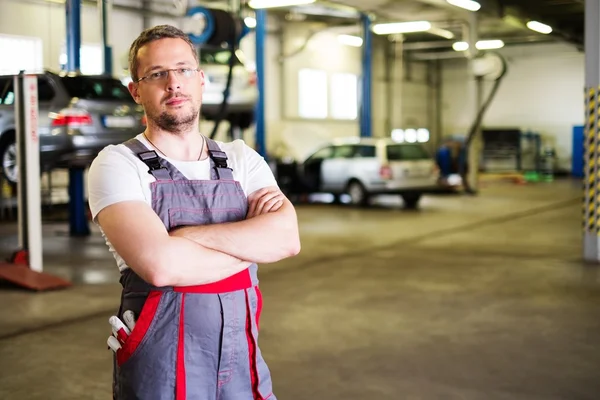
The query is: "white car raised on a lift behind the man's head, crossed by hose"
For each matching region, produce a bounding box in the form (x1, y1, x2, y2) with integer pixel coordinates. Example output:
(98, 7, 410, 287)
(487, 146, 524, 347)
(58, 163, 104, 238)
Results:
(198, 47, 258, 129)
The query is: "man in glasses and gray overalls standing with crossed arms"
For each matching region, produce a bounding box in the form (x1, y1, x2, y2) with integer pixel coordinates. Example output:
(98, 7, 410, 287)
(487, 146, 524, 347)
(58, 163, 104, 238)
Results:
(88, 25, 300, 400)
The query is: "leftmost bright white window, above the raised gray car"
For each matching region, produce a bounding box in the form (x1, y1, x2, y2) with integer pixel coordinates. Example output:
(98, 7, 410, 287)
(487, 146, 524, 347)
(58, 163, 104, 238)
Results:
(0, 35, 44, 75)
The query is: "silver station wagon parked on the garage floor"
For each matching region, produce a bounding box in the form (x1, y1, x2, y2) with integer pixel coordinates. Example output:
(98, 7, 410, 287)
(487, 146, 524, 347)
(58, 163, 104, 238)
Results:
(298, 138, 439, 208)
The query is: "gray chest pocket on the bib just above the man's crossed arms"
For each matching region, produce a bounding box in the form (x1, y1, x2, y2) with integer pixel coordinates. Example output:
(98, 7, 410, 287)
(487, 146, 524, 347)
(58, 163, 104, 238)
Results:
(169, 207, 245, 230)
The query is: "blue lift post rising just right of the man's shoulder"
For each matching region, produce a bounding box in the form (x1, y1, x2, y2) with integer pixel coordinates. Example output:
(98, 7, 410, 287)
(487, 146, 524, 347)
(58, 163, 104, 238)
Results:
(255, 10, 267, 158)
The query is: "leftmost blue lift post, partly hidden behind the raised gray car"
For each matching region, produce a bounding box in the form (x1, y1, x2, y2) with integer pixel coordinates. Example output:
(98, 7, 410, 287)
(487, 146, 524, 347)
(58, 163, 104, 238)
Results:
(66, 0, 90, 236)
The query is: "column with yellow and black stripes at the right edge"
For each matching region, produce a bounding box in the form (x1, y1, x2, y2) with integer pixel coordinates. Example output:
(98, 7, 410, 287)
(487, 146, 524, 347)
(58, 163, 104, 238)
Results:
(583, 0, 600, 262)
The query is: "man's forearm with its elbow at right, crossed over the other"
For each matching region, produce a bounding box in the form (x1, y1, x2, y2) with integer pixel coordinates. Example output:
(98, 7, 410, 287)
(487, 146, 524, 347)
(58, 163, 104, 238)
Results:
(170, 200, 300, 263)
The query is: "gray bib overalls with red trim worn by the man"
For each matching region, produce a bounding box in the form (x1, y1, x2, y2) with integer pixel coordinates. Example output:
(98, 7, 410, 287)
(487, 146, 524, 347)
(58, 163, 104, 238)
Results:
(113, 138, 276, 400)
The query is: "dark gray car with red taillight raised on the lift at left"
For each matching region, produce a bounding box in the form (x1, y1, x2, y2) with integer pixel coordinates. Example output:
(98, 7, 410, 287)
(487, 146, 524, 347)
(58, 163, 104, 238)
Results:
(0, 71, 145, 184)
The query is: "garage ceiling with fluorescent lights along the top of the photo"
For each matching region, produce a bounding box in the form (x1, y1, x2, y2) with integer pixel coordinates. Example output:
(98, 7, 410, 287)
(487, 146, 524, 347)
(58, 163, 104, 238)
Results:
(125, 0, 585, 52)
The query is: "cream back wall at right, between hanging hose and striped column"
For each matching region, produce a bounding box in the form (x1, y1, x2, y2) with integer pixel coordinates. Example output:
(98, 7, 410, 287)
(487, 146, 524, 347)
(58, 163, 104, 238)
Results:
(443, 44, 585, 170)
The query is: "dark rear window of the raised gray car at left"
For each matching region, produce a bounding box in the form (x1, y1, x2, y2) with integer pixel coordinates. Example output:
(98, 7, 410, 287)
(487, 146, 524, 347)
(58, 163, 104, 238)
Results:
(61, 76, 133, 101)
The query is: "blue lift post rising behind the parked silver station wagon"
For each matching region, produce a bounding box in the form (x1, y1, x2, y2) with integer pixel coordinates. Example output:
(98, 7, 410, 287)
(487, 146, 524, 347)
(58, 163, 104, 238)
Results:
(360, 14, 373, 137)
